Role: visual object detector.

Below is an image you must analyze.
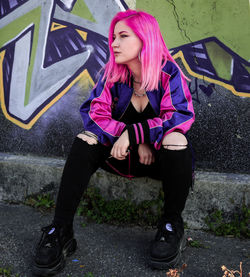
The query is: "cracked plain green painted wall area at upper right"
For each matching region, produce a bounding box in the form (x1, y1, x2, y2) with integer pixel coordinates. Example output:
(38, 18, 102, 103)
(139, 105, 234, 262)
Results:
(136, 0, 250, 59)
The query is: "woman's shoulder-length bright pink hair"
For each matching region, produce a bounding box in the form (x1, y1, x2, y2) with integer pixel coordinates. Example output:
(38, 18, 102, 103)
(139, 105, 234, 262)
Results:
(103, 10, 184, 90)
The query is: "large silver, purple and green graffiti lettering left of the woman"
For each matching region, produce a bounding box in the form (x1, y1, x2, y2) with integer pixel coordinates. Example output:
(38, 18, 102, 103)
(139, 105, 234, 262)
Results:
(0, 0, 126, 129)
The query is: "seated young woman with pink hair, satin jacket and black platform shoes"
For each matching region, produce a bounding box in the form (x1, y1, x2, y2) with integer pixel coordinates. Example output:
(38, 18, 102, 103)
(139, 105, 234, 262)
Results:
(34, 10, 194, 276)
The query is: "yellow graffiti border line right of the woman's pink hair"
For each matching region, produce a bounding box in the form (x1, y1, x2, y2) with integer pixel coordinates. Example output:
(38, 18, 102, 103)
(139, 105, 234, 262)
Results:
(173, 51, 250, 97)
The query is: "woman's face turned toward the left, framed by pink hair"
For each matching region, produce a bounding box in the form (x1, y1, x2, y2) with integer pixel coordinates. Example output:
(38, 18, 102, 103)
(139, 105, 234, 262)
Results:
(111, 21, 142, 64)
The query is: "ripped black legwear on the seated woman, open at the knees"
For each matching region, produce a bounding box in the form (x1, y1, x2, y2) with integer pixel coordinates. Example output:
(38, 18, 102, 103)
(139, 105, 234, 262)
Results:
(54, 137, 192, 225)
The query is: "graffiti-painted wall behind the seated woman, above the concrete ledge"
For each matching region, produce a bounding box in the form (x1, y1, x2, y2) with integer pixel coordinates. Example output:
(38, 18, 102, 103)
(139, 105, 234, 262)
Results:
(0, 0, 250, 172)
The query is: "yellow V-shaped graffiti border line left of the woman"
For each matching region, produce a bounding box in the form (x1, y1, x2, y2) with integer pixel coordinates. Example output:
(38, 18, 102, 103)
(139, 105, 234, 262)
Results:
(0, 47, 94, 130)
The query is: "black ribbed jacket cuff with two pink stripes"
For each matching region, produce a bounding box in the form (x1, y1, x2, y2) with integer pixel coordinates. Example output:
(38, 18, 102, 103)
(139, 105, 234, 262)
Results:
(126, 121, 150, 146)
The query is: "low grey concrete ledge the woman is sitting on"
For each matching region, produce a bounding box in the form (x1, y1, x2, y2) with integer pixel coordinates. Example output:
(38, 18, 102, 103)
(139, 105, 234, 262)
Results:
(0, 153, 250, 229)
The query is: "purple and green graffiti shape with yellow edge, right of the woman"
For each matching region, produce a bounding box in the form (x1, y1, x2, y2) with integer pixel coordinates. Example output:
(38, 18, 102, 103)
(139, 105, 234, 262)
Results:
(172, 37, 250, 97)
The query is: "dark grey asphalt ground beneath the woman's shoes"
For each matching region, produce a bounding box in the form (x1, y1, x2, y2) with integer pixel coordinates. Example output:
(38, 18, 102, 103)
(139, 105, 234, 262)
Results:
(0, 203, 250, 277)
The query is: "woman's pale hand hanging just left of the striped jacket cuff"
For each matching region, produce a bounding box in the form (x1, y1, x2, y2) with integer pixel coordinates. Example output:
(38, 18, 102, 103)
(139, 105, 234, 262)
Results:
(110, 130, 129, 160)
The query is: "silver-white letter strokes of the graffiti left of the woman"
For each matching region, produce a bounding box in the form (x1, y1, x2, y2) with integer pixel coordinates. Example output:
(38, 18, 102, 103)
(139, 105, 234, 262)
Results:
(0, 0, 126, 129)
